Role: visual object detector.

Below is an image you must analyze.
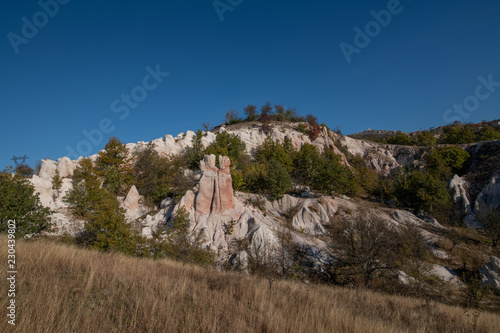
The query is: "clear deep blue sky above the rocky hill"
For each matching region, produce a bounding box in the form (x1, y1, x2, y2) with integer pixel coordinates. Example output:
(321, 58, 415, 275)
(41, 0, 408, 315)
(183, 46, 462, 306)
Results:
(0, 0, 500, 168)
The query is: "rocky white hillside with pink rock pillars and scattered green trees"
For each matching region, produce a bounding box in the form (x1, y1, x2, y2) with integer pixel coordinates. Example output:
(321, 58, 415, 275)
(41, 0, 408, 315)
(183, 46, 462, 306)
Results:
(0, 116, 500, 324)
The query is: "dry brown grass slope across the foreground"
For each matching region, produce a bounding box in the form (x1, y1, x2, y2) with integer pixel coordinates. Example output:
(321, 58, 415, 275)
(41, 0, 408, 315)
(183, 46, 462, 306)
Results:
(0, 236, 500, 333)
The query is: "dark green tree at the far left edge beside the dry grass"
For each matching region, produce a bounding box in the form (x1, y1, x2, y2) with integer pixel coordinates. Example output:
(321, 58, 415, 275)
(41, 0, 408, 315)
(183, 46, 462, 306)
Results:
(0, 168, 52, 236)
